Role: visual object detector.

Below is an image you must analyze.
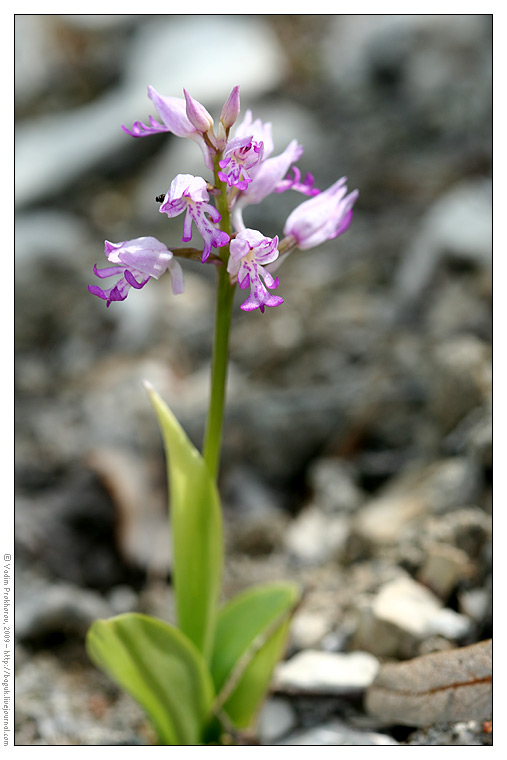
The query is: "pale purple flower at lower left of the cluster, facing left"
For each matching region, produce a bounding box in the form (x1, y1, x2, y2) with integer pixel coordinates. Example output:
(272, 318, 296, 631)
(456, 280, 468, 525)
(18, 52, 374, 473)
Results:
(88, 237, 184, 307)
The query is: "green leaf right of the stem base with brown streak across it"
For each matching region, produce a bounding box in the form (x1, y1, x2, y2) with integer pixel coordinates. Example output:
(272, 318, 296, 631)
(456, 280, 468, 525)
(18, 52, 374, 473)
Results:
(211, 583, 300, 728)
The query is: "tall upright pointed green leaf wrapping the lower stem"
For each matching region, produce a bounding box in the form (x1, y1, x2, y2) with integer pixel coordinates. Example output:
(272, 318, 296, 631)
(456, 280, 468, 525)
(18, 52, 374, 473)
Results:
(147, 386, 223, 659)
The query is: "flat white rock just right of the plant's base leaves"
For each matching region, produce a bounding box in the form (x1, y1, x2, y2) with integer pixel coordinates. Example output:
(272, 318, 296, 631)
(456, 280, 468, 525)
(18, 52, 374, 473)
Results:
(273, 649, 378, 694)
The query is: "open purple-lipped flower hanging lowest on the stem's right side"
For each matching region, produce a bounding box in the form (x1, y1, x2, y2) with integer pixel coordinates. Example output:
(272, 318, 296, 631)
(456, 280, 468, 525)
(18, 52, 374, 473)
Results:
(227, 229, 283, 313)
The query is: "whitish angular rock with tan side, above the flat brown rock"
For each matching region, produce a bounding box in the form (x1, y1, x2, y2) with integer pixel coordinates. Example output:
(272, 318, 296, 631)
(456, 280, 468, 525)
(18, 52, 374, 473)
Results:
(353, 576, 471, 658)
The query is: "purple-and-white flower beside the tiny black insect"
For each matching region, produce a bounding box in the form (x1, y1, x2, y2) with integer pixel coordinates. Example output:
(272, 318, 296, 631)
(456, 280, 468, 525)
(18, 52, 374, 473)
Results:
(160, 174, 229, 262)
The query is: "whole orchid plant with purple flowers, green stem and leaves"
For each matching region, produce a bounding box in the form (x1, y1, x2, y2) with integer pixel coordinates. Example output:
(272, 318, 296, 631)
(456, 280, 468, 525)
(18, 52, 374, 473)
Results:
(87, 87, 358, 745)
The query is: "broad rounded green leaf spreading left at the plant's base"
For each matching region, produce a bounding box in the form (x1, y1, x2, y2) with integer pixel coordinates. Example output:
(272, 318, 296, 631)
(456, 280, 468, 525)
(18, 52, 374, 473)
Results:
(86, 613, 214, 745)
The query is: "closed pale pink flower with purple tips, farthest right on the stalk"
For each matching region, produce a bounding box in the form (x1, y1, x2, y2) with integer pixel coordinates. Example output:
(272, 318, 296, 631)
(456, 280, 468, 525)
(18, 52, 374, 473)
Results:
(283, 177, 359, 251)
